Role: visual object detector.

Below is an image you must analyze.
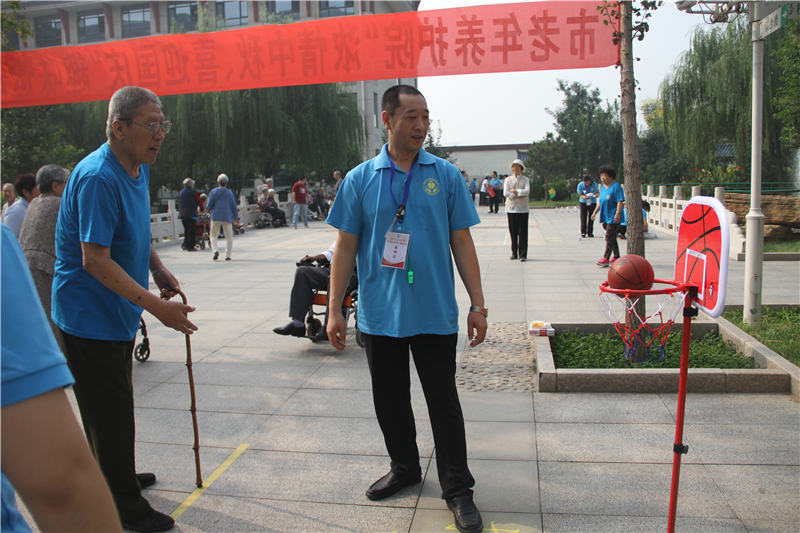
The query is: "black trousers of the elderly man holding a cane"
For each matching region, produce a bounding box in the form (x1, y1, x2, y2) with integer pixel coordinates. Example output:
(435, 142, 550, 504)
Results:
(61, 331, 151, 520)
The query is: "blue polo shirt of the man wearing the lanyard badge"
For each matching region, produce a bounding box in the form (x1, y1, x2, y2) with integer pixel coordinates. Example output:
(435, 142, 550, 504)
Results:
(328, 145, 480, 337)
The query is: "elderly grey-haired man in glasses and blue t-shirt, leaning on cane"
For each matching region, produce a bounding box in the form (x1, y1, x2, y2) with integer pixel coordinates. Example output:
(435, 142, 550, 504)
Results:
(52, 87, 197, 531)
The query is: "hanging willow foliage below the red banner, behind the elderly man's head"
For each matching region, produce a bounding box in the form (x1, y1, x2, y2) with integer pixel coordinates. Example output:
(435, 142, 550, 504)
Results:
(2, 84, 362, 197)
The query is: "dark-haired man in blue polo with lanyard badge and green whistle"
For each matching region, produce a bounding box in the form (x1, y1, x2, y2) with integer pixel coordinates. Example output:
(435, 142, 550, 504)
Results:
(327, 85, 487, 532)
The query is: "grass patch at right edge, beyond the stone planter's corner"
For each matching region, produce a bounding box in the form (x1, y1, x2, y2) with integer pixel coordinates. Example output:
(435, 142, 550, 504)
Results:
(722, 306, 800, 366)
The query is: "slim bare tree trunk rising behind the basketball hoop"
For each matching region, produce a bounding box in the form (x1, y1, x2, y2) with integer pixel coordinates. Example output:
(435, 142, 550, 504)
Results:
(619, 1, 648, 362)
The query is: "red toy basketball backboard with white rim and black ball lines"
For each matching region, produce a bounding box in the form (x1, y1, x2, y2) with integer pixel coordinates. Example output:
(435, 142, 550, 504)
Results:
(675, 196, 730, 317)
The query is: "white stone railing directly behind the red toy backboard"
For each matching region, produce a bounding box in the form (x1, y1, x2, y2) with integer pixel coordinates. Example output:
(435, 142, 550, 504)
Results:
(642, 185, 745, 261)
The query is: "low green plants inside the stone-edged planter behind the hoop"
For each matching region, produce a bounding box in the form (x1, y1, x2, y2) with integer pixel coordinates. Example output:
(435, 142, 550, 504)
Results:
(550, 331, 753, 368)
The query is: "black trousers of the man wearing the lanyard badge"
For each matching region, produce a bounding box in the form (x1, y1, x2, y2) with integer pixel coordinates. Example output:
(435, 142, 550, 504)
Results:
(364, 333, 475, 499)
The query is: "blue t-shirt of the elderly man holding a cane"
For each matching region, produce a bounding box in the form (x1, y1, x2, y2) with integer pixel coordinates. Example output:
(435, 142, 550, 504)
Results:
(52, 144, 150, 341)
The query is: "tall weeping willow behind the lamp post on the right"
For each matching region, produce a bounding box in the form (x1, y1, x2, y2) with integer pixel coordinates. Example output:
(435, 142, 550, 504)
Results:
(660, 19, 800, 180)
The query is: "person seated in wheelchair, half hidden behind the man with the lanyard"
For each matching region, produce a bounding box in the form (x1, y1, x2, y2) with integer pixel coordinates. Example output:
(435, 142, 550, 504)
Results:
(272, 242, 336, 341)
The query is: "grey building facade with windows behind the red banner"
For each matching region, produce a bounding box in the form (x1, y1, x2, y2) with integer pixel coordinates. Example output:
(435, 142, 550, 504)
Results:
(7, 0, 419, 158)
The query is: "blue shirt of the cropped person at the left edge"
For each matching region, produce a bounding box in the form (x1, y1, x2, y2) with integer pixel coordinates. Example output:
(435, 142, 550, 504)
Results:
(0, 224, 73, 532)
